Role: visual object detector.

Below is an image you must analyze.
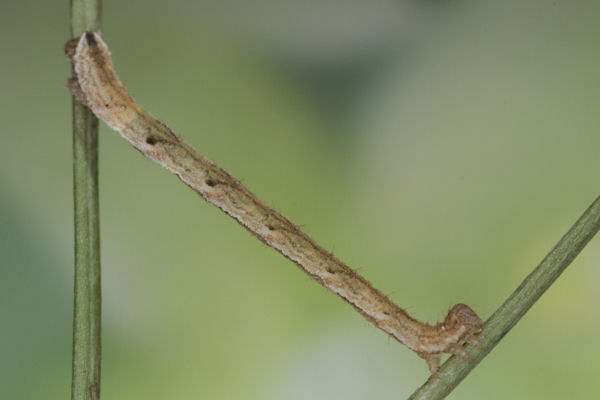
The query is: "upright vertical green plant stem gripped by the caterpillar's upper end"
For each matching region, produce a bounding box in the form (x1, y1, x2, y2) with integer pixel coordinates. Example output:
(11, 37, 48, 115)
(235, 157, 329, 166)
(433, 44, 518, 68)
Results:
(71, 0, 102, 400)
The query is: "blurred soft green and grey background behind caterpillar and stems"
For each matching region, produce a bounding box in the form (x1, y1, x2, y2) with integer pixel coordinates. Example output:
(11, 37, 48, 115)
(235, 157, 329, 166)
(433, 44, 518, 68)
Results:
(0, 0, 600, 400)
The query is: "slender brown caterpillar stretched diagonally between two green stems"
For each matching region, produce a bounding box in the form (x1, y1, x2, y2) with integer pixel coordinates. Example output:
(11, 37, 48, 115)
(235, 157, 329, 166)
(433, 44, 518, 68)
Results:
(65, 32, 483, 375)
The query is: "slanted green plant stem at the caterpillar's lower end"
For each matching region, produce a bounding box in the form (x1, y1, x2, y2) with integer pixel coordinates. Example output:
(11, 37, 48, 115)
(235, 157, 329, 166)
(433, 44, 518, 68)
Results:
(409, 197, 600, 400)
